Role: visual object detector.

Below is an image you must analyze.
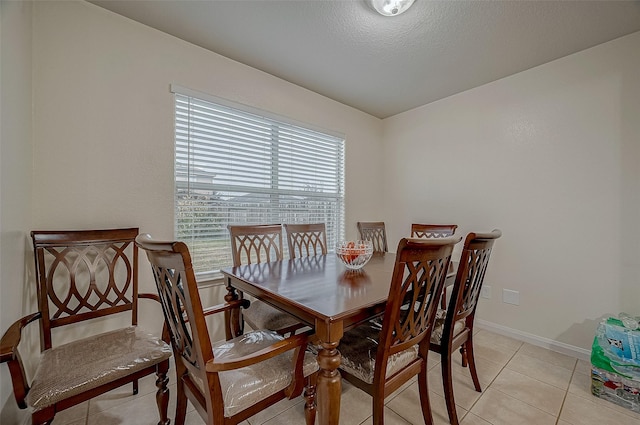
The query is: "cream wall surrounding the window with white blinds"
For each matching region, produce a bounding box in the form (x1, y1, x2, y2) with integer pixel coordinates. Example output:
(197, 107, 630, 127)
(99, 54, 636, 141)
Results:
(28, 1, 382, 335)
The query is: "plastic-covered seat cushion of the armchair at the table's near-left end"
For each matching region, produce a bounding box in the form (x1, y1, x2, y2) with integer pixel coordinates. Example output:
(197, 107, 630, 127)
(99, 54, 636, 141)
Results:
(192, 330, 318, 417)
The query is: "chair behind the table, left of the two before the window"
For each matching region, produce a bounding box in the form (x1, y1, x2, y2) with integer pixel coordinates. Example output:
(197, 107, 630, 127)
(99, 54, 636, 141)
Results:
(228, 224, 304, 335)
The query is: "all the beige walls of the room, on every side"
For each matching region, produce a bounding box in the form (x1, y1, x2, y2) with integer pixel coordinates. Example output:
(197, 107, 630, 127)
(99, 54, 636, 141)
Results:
(0, 1, 640, 414)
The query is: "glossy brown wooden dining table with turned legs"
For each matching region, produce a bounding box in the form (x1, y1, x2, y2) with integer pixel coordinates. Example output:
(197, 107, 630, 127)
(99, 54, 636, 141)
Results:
(221, 253, 455, 425)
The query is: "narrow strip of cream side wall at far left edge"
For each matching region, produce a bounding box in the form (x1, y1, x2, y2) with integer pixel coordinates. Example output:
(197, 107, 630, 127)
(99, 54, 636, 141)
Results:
(0, 1, 33, 424)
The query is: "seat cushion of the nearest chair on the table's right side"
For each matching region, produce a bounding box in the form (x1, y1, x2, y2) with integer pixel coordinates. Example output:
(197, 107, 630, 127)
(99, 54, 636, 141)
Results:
(338, 319, 418, 384)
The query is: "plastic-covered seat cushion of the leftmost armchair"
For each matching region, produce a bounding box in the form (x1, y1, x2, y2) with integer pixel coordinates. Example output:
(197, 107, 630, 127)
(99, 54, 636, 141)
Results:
(27, 326, 171, 410)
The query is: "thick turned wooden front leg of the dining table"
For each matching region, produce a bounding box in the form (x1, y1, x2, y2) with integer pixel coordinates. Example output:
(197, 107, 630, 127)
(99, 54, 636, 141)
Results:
(316, 342, 342, 425)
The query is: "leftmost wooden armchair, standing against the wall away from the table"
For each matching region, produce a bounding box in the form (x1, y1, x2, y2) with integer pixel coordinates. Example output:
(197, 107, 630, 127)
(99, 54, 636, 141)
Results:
(0, 228, 171, 425)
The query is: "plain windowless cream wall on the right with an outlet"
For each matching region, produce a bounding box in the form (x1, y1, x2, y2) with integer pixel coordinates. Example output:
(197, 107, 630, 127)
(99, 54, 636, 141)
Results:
(383, 33, 640, 349)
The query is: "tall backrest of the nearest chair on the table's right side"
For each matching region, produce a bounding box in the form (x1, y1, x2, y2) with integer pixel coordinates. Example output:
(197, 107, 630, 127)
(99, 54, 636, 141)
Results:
(374, 237, 462, 372)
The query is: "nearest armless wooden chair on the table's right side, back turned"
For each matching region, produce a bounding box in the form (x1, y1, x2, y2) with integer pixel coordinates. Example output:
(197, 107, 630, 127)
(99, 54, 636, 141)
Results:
(338, 237, 462, 425)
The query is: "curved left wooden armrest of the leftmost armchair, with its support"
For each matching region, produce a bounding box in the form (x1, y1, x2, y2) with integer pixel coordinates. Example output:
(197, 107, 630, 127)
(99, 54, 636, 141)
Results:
(0, 312, 42, 409)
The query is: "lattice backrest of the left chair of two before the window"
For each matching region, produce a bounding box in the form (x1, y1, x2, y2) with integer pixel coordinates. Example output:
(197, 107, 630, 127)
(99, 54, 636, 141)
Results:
(228, 224, 283, 267)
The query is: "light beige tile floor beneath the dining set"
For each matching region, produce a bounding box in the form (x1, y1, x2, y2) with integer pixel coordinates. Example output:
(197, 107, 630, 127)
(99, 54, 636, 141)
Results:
(54, 330, 640, 425)
